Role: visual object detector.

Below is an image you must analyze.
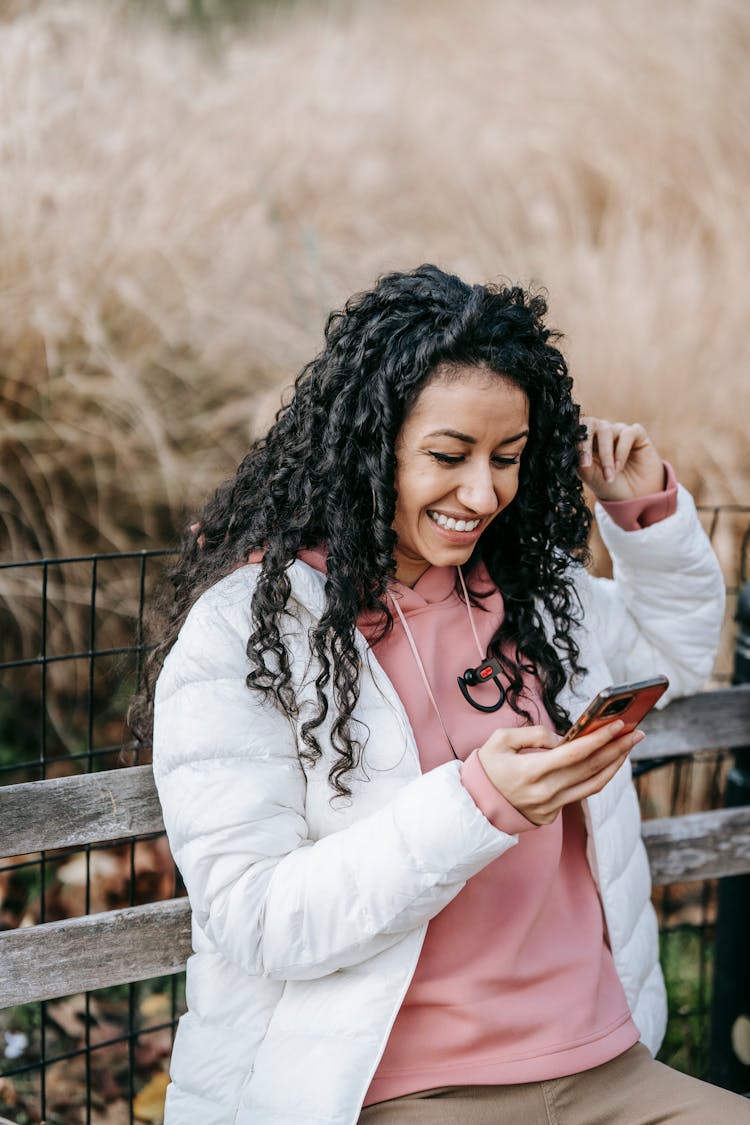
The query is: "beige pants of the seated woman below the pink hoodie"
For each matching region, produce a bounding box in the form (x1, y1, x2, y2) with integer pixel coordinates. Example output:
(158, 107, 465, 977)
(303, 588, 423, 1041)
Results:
(360, 1043, 750, 1125)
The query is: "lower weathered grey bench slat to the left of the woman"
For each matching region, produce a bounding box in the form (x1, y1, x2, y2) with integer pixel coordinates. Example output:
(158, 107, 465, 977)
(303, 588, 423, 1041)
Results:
(0, 899, 192, 1008)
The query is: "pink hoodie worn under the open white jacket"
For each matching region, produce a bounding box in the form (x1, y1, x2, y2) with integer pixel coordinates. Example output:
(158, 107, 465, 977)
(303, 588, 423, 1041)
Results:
(278, 467, 677, 1105)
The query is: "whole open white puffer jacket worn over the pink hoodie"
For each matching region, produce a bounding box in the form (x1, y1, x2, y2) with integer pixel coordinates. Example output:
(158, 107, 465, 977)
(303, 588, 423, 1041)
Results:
(154, 488, 724, 1125)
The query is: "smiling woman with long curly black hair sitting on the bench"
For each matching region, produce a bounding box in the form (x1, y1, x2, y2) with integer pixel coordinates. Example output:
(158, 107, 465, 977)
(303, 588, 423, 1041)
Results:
(146, 266, 750, 1125)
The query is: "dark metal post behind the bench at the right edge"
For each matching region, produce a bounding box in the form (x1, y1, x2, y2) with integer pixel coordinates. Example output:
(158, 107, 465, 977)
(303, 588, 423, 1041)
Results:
(710, 582, 750, 1094)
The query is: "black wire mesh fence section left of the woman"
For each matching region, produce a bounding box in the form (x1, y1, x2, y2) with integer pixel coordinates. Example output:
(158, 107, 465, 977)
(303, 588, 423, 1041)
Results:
(0, 551, 184, 1125)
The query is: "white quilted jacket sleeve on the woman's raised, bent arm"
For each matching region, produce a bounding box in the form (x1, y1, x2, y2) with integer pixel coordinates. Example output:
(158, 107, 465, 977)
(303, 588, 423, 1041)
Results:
(584, 487, 725, 705)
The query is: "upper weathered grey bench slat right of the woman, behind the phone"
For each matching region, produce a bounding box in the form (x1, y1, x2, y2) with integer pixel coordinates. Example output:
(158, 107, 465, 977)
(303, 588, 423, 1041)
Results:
(632, 684, 750, 761)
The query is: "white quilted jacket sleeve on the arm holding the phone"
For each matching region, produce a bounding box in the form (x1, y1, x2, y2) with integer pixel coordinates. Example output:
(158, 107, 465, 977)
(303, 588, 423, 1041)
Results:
(154, 587, 517, 980)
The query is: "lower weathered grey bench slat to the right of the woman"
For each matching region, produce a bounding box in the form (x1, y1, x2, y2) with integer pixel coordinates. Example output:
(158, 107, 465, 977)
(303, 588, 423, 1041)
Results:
(642, 806, 750, 887)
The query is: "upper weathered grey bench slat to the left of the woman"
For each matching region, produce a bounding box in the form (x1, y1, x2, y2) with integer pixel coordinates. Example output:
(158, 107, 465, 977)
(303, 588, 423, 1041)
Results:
(0, 766, 164, 856)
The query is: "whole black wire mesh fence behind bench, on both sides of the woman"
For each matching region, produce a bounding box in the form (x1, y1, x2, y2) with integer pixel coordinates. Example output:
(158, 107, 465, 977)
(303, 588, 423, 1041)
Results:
(0, 505, 750, 1125)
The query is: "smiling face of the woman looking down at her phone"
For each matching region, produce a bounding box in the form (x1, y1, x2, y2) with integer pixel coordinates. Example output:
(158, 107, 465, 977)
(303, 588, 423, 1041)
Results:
(394, 367, 528, 586)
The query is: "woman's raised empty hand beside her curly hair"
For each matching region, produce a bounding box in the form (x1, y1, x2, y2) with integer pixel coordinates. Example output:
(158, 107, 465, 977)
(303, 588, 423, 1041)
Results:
(578, 417, 665, 501)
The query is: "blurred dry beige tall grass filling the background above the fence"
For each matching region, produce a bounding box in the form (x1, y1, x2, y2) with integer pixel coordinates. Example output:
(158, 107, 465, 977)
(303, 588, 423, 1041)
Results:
(0, 0, 750, 567)
